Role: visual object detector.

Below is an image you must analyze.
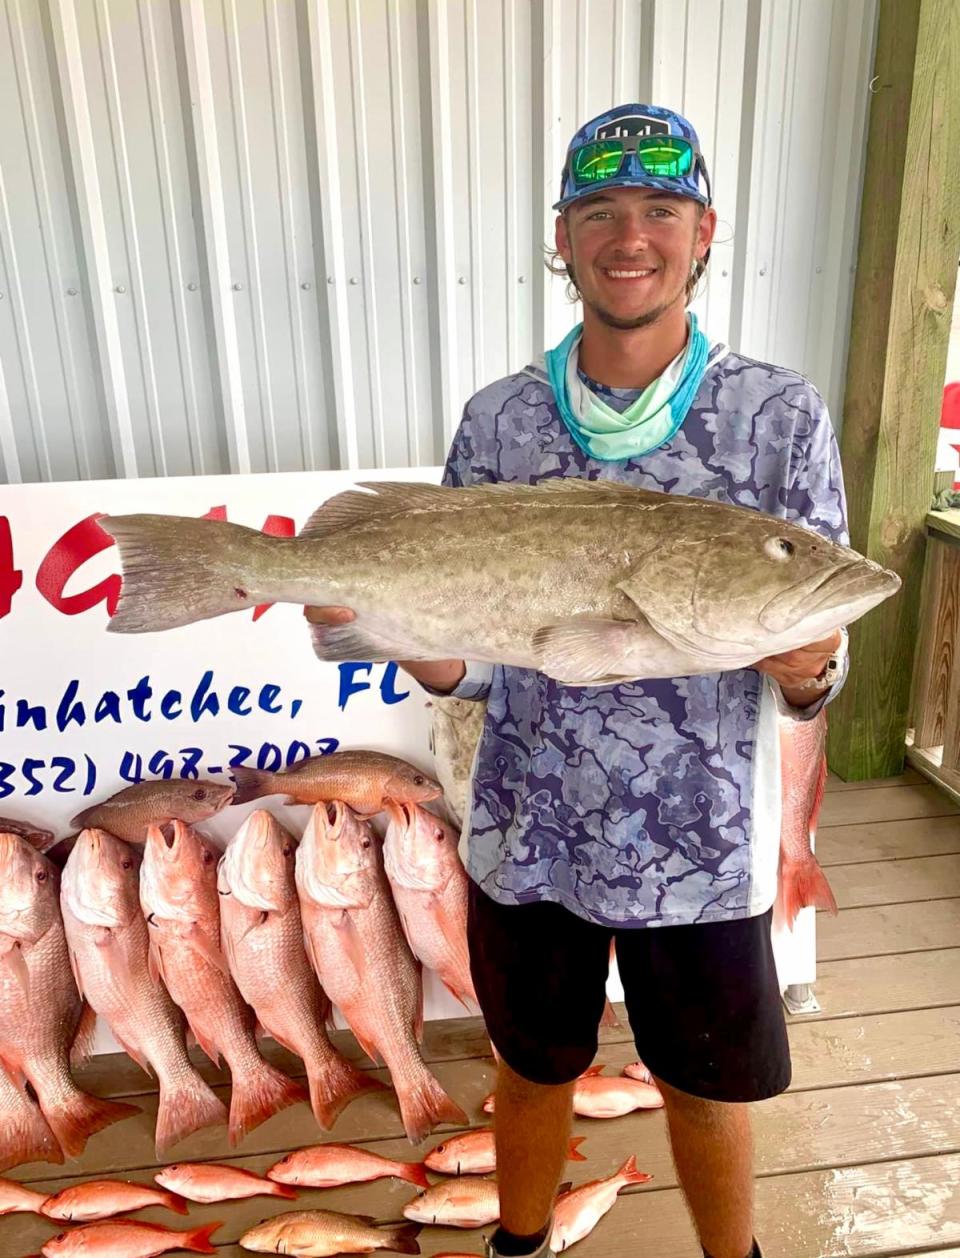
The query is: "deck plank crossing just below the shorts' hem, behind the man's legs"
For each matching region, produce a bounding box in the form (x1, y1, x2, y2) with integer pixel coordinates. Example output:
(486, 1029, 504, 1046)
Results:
(7, 1074, 960, 1252)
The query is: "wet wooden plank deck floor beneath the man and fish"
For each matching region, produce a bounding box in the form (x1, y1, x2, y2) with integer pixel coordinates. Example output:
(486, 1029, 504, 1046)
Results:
(0, 771, 960, 1258)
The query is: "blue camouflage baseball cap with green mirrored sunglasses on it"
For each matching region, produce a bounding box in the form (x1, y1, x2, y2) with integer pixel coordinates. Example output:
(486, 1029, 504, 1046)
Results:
(554, 104, 711, 210)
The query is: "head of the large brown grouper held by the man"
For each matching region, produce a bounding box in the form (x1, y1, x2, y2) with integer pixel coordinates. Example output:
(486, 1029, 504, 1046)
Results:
(623, 503, 900, 668)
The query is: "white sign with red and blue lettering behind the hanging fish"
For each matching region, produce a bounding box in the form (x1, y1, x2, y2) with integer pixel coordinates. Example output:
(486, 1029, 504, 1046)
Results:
(0, 468, 480, 1052)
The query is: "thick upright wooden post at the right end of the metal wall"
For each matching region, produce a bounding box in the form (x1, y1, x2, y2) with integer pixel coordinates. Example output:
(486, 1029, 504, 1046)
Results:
(829, 0, 960, 780)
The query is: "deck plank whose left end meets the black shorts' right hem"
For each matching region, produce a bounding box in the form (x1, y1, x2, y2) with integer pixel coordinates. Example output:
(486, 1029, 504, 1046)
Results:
(788, 1006, 960, 1091)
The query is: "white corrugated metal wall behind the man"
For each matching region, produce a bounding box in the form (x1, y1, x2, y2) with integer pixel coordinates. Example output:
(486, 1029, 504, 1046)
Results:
(0, 0, 876, 482)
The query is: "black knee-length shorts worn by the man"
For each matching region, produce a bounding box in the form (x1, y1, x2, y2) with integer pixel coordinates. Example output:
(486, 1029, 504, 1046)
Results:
(468, 882, 790, 1101)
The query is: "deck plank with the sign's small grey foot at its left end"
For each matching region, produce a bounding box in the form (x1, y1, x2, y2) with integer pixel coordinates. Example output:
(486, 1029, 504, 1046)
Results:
(803, 947, 960, 1020)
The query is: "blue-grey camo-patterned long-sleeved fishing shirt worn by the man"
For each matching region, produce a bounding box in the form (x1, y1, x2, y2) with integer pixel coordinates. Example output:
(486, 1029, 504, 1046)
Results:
(444, 345, 848, 927)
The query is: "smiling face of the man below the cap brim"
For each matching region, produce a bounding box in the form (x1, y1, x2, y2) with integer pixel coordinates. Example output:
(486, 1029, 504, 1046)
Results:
(556, 187, 716, 328)
